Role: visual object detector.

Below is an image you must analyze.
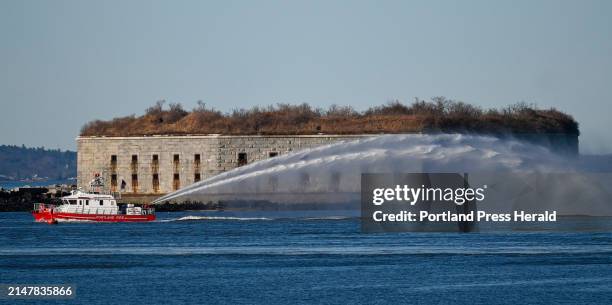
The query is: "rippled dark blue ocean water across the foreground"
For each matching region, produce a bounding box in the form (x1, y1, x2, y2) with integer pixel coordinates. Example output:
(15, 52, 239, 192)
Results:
(0, 212, 612, 305)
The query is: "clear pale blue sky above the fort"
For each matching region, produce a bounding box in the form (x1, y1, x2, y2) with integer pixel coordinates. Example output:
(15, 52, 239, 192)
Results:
(0, 0, 612, 153)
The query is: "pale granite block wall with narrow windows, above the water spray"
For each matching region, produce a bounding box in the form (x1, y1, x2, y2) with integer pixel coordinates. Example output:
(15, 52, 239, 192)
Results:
(77, 135, 367, 196)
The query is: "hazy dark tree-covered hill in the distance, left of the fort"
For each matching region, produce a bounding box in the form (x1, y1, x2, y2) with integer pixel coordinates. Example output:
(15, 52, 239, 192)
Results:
(0, 145, 76, 180)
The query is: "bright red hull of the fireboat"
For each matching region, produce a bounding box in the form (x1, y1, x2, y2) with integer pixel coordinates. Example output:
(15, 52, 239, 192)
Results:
(32, 211, 155, 224)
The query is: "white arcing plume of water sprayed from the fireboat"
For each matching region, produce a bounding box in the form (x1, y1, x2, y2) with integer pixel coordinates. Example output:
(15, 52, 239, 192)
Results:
(155, 134, 592, 207)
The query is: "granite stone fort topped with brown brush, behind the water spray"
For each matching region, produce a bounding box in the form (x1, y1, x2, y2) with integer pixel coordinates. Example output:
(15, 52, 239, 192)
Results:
(77, 97, 580, 202)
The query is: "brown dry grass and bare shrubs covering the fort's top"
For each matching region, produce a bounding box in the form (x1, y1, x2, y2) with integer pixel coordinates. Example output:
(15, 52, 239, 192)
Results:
(81, 97, 579, 136)
